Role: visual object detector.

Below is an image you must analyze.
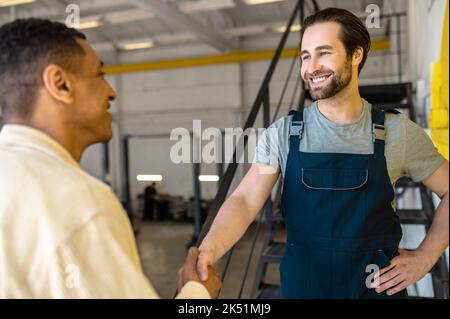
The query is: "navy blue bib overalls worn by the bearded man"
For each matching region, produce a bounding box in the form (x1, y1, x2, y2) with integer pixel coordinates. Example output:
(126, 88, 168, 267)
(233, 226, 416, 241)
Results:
(280, 108, 406, 298)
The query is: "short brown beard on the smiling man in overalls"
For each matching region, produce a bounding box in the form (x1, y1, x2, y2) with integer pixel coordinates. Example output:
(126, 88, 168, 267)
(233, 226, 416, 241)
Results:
(309, 59, 352, 100)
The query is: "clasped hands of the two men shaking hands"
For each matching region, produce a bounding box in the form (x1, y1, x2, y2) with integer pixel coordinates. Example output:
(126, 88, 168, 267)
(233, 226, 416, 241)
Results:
(178, 247, 222, 298)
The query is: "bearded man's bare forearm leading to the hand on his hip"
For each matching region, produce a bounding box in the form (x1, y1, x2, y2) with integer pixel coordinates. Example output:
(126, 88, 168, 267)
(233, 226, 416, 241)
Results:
(416, 192, 449, 268)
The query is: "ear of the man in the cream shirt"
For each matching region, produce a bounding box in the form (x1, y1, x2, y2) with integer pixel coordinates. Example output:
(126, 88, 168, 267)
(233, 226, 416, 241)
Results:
(42, 64, 74, 104)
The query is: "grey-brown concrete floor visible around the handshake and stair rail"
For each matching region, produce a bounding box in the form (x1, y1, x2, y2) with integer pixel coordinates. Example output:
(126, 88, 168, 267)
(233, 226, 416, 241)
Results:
(136, 221, 279, 299)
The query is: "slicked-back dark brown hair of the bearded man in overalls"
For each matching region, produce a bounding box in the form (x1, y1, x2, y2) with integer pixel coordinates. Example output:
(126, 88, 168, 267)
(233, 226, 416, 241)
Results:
(302, 8, 370, 74)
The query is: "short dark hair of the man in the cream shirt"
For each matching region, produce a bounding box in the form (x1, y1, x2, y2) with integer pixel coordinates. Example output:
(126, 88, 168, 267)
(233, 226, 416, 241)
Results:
(0, 18, 86, 118)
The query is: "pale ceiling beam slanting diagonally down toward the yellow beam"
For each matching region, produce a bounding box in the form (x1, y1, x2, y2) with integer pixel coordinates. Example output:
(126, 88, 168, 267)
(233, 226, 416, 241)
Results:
(130, 0, 235, 52)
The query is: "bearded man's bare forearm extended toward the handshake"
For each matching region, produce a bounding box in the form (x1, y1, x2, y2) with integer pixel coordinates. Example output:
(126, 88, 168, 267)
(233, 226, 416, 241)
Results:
(199, 195, 253, 262)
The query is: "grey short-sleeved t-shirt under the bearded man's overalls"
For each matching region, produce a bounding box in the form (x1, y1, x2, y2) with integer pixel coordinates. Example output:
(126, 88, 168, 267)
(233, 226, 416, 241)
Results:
(253, 100, 444, 184)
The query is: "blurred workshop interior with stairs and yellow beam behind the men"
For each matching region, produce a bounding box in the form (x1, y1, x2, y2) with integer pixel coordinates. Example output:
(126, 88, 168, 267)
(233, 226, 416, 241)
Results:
(0, 0, 448, 299)
